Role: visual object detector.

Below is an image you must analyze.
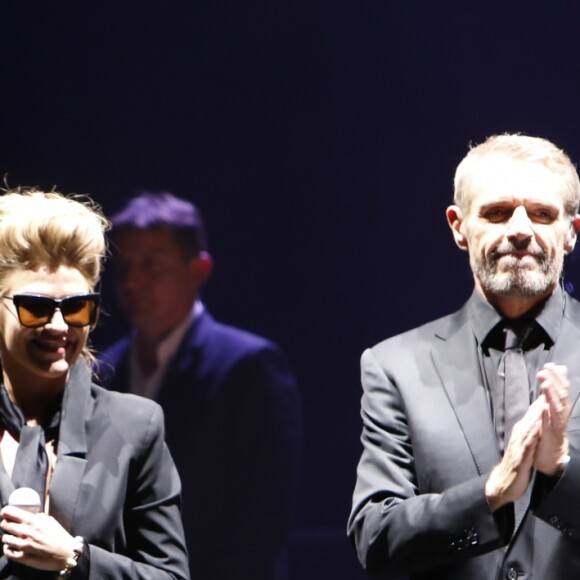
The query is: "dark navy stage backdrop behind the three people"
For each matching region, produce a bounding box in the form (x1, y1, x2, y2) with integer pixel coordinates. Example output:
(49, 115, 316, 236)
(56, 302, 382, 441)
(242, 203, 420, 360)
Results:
(0, 0, 580, 580)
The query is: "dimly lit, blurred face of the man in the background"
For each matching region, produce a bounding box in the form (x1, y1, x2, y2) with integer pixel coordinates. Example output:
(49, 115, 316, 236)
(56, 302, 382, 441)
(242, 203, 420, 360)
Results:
(115, 227, 206, 339)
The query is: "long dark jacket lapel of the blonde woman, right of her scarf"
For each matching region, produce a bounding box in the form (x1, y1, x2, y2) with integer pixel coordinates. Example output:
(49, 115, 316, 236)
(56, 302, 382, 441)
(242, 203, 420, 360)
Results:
(49, 362, 91, 530)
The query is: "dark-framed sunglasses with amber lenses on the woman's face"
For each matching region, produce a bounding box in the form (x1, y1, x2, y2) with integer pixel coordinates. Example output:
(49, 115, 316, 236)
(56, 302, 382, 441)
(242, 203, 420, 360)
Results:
(1, 294, 99, 328)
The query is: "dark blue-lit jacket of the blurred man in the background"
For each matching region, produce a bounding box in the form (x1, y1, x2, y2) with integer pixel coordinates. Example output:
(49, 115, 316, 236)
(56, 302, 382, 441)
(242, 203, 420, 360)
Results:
(101, 312, 301, 580)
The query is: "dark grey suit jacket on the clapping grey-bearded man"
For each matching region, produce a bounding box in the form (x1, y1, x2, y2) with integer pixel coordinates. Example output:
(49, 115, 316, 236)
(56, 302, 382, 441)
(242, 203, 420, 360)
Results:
(348, 296, 580, 580)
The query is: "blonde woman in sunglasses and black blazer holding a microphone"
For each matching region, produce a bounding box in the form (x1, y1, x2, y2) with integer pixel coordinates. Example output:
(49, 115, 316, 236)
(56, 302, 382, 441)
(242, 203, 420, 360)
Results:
(0, 189, 189, 579)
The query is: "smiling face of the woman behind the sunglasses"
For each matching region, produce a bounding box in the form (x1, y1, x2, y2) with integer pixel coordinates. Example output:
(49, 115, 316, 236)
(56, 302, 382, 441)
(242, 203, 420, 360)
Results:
(0, 266, 89, 386)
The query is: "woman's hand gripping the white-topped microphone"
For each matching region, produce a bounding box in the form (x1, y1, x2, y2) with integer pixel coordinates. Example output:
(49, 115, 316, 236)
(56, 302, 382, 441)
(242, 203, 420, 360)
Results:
(0, 505, 76, 572)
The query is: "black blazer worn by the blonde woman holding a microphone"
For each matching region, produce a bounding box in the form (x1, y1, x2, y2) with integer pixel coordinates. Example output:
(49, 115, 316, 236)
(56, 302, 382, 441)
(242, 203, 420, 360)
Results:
(0, 363, 189, 580)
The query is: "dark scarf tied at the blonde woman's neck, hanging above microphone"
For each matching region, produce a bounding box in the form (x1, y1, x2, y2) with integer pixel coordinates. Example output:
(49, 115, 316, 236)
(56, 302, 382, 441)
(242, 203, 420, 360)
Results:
(0, 385, 60, 510)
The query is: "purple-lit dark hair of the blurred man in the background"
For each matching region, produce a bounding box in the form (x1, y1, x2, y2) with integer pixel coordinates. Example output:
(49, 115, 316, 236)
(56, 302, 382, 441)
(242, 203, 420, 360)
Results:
(111, 191, 208, 257)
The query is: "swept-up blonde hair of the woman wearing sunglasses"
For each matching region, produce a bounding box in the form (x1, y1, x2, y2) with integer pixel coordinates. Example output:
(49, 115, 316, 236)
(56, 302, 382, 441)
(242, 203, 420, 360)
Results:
(0, 187, 110, 359)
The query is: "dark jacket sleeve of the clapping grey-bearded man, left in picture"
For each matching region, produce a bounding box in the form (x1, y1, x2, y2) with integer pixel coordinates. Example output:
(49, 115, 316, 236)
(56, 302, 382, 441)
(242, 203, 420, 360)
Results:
(348, 350, 513, 575)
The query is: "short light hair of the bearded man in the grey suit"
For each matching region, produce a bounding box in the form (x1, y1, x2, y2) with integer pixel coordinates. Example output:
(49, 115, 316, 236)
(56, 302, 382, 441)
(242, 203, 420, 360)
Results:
(453, 133, 580, 217)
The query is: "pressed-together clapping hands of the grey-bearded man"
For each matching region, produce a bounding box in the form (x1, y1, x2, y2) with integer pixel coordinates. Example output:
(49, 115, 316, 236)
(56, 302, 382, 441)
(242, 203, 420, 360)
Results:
(485, 363, 570, 511)
